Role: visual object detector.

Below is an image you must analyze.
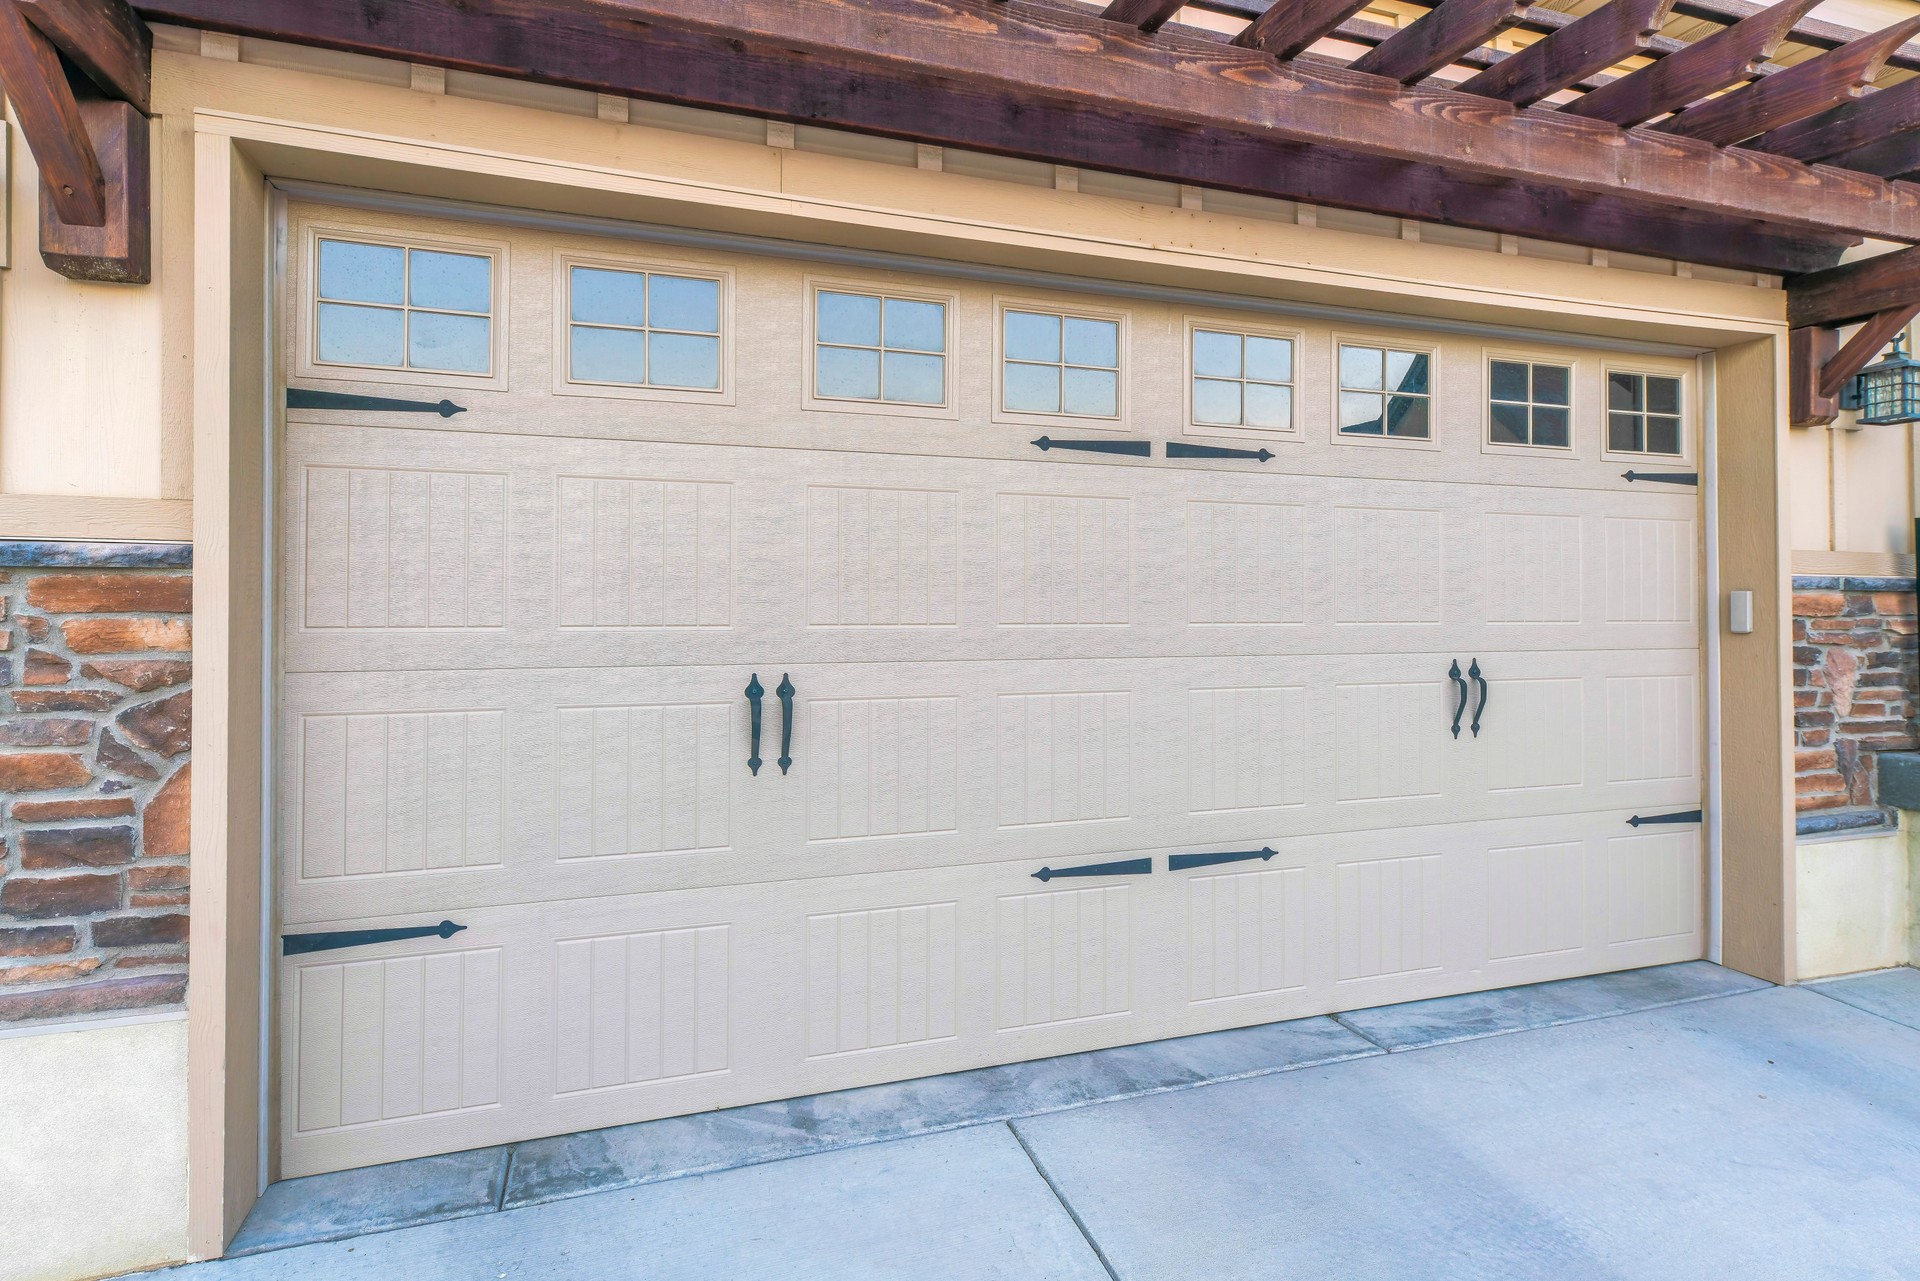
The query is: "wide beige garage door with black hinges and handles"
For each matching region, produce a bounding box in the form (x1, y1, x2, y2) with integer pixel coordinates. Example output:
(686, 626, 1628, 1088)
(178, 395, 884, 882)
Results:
(276, 207, 1703, 1175)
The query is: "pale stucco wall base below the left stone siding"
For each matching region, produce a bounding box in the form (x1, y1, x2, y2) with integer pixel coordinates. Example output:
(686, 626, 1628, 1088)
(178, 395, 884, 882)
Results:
(0, 1016, 186, 1281)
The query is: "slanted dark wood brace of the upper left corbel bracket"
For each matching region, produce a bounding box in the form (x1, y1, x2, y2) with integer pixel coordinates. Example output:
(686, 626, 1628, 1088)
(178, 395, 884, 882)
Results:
(0, 0, 108, 227)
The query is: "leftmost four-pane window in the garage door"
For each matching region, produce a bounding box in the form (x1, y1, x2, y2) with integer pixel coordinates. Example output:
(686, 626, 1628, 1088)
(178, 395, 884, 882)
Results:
(313, 238, 493, 375)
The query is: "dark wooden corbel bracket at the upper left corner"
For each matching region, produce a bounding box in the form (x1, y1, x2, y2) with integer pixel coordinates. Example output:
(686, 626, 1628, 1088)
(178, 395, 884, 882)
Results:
(0, 0, 154, 284)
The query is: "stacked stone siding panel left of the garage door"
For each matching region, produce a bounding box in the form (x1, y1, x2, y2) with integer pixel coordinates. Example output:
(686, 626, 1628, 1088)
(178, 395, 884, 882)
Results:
(0, 568, 194, 1024)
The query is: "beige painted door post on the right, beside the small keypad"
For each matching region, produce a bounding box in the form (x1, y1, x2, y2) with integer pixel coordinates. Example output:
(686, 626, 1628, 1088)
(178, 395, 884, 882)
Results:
(1713, 334, 1795, 983)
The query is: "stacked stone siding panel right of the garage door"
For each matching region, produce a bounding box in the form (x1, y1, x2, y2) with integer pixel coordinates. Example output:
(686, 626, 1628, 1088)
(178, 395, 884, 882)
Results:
(1793, 578, 1920, 812)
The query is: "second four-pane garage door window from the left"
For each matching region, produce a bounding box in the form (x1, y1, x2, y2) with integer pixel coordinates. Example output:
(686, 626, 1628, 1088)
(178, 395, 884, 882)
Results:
(566, 267, 720, 392)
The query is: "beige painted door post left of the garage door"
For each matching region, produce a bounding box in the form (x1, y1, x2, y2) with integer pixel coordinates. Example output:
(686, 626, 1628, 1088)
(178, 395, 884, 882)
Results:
(186, 134, 271, 1258)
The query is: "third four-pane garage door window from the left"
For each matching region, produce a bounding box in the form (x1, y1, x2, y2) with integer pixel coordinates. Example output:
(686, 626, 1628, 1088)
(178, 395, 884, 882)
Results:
(814, 288, 947, 405)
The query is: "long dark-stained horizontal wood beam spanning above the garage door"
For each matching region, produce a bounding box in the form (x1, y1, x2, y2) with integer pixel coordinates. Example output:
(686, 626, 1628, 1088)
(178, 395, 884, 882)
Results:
(123, 0, 1920, 257)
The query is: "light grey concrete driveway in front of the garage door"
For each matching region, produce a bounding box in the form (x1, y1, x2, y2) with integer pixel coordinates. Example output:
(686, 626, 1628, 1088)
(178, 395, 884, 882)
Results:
(135, 962, 1920, 1281)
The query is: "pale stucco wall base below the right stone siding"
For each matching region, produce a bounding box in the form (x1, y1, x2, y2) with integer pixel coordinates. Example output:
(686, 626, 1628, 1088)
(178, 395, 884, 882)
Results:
(1797, 812, 1914, 979)
